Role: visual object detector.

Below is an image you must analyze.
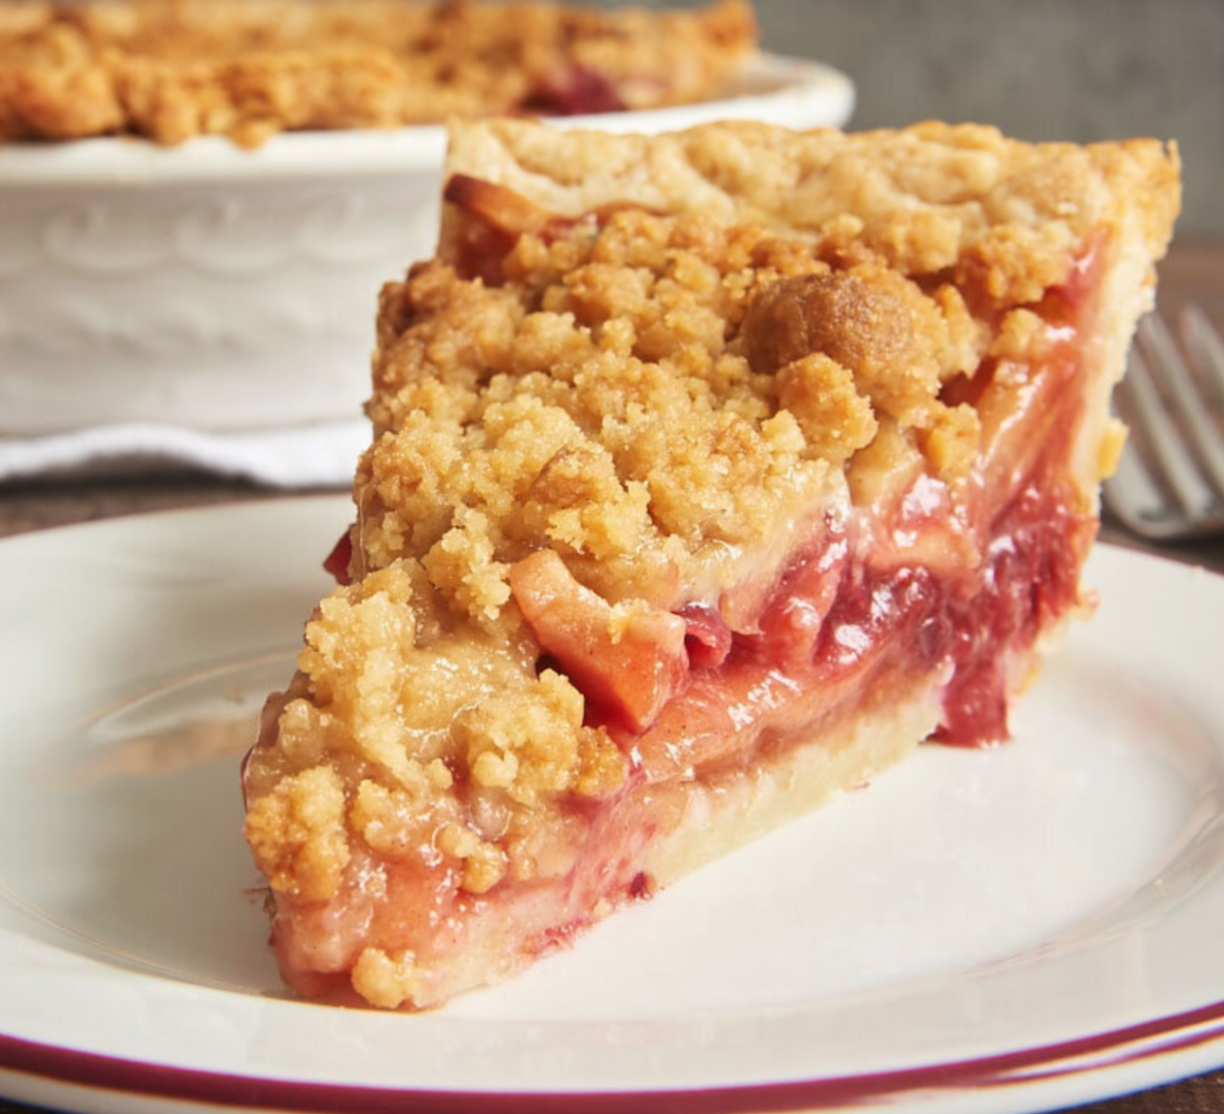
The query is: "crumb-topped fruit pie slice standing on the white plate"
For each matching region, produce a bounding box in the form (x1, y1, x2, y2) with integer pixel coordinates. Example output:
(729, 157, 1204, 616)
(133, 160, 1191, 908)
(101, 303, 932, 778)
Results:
(244, 122, 1179, 1007)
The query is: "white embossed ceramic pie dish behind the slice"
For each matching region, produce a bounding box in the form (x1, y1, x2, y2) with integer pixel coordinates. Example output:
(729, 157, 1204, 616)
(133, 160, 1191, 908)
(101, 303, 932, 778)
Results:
(0, 55, 854, 438)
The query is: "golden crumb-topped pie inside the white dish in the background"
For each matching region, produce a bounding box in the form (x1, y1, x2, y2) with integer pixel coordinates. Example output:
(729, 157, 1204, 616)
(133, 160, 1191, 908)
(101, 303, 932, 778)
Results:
(0, 0, 756, 146)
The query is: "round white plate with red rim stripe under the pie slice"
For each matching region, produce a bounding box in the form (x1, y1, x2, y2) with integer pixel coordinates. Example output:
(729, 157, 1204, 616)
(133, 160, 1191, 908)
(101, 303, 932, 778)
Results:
(0, 497, 1224, 1114)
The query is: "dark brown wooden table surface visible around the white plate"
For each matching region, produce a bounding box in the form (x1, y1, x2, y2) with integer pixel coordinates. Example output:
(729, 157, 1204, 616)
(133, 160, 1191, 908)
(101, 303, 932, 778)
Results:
(0, 244, 1224, 1114)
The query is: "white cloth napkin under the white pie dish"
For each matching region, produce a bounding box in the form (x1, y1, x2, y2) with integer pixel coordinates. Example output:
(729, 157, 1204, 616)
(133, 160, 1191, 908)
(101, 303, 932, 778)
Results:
(0, 419, 370, 487)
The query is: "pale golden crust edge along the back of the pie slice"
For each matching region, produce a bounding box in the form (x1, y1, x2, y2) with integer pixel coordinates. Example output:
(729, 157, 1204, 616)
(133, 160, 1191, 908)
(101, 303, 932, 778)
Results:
(443, 120, 1181, 304)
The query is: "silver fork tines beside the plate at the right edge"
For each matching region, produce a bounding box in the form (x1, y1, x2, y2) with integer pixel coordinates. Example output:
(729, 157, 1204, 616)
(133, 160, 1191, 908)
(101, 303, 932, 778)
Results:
(1104, 306, 1224, 541)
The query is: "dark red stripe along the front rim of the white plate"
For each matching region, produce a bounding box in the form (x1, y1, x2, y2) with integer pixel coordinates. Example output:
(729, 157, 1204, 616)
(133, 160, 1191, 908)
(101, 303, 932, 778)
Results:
(0, 1001, 1224, 1114)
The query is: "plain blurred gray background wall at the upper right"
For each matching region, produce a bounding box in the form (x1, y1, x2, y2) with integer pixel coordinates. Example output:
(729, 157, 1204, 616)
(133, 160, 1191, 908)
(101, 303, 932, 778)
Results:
(603, 0, 1224, 236)
